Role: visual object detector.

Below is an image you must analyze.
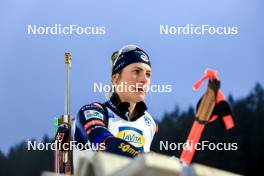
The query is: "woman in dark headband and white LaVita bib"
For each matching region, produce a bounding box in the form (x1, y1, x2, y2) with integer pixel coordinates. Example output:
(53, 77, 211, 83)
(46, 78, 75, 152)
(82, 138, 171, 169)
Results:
(74, 45, 157, 157)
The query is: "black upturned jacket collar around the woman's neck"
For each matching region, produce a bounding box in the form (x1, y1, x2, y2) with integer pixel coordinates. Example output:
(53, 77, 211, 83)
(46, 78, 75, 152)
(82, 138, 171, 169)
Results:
(105, 93, 147, 121)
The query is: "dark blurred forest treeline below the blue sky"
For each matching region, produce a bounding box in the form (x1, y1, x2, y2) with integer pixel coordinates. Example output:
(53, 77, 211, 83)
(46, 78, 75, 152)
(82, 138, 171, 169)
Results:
(0, 83, 264, 176)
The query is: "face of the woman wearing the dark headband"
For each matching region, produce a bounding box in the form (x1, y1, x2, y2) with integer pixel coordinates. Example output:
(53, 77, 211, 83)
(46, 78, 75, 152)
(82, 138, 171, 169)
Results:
(112, 63, 151, 103)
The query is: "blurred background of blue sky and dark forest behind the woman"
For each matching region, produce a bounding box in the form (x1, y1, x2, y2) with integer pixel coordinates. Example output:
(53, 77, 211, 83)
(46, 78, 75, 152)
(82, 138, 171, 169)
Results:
(0, 0, 264, 175)
